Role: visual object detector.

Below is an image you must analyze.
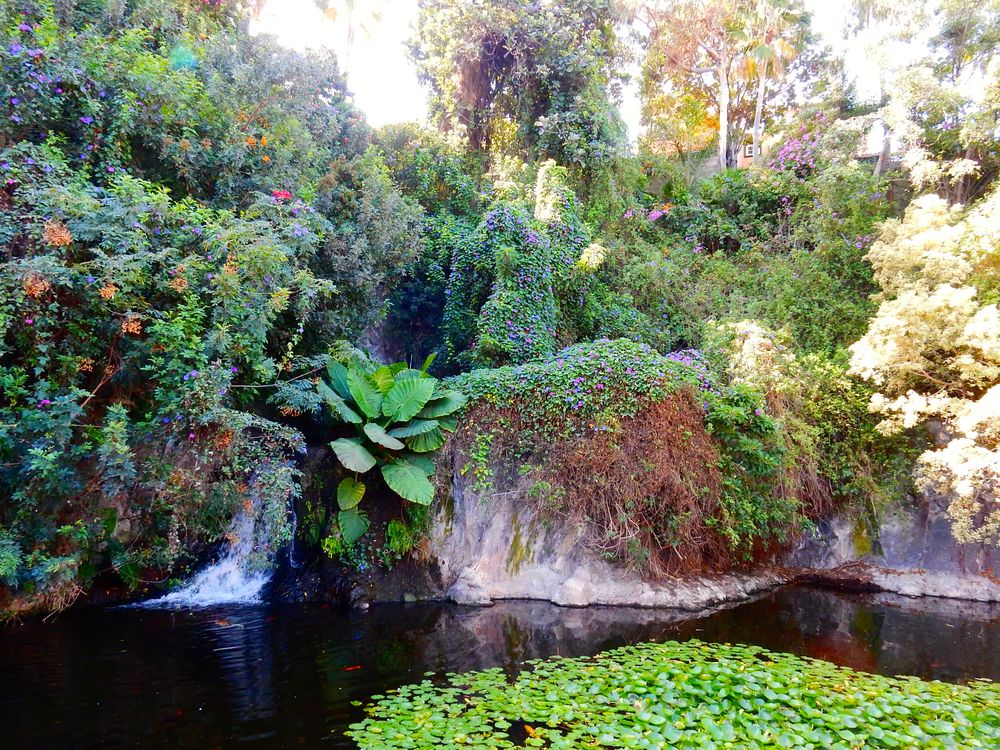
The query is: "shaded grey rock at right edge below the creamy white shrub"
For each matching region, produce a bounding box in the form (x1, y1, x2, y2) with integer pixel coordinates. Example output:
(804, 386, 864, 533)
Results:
(785, 500, 1000, 602)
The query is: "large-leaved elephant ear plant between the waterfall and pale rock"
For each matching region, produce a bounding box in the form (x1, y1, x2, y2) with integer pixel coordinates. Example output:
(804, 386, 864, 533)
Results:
(317, 355, 466, 544)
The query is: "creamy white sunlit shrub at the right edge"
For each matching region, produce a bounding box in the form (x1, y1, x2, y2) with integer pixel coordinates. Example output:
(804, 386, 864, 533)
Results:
(850, 190, 1000, 544)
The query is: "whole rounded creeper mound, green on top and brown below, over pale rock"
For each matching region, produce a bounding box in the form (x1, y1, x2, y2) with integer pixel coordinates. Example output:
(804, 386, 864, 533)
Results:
(452, 339, 807, 574)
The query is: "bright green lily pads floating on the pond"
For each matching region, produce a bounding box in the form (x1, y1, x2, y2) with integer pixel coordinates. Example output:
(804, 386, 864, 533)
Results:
(349, 641, 1000, 750)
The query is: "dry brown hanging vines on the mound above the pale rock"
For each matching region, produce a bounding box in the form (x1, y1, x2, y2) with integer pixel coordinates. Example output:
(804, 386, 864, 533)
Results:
(454, 390, 780, 578)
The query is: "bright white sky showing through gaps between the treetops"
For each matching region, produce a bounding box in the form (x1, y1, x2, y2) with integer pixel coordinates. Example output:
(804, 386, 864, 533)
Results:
(252, 0, 914, 141)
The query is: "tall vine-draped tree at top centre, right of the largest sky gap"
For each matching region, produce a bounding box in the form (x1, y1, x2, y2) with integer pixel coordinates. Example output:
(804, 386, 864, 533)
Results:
(410, 0, 624, 165)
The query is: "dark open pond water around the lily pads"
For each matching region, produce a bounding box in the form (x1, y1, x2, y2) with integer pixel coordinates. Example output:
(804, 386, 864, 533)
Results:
(0, 588, 1000, 750)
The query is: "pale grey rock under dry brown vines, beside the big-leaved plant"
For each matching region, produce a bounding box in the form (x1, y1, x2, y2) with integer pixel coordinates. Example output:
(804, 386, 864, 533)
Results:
(422, 475, 788, 610)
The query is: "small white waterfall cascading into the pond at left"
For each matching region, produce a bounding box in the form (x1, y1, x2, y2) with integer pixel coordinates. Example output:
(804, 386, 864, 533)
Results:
(140, 505, 271, 607)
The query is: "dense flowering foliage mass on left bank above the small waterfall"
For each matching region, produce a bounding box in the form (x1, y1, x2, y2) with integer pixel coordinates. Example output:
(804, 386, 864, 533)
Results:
(0, 0, 420, 607)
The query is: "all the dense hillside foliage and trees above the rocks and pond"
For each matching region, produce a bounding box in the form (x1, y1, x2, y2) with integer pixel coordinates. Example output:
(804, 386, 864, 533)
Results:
(0, 0, 1000, 606)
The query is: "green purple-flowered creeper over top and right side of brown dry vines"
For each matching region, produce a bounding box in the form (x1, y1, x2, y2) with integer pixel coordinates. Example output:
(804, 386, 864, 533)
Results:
(450, 340, 788, 558)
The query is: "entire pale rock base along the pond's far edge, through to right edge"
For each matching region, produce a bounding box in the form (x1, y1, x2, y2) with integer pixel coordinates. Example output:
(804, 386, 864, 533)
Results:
(410, 474, 1000, 610)
